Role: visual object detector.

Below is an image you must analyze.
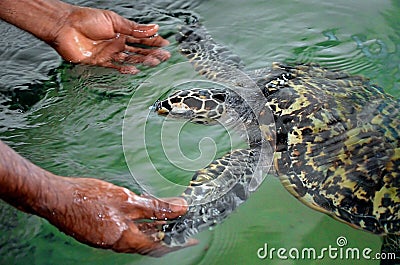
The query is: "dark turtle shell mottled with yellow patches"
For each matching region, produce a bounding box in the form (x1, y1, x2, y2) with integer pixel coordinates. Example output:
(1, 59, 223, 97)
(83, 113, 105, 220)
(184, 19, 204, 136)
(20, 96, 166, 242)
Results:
(259, 64, 400, 234)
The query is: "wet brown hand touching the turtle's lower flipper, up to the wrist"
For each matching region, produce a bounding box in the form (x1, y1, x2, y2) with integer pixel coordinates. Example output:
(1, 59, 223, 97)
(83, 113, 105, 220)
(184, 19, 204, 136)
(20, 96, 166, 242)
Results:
(43, 177, 197, 256)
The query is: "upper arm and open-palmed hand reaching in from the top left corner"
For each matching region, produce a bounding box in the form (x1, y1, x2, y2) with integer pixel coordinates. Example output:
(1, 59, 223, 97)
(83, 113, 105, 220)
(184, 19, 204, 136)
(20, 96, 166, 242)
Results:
(0, 0, 170, 74)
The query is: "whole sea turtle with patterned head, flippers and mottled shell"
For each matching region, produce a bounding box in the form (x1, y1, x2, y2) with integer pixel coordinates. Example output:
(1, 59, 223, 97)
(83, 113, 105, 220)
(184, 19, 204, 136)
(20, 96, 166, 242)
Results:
(155, 24, 400, 255)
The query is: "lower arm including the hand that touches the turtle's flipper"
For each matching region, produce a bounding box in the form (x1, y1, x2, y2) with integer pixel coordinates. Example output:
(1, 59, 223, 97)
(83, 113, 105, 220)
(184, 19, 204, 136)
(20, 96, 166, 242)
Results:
(0, 141, 193, 256)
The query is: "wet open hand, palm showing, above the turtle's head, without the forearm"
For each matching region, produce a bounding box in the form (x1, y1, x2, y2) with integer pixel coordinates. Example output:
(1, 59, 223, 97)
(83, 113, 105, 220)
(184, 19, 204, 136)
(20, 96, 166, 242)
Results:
(49, 6, 170, 74)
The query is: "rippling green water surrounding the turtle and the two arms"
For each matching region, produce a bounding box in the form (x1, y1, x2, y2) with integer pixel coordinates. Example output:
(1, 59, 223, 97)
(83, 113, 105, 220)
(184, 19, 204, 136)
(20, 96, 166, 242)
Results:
(0, 0, 400, 264)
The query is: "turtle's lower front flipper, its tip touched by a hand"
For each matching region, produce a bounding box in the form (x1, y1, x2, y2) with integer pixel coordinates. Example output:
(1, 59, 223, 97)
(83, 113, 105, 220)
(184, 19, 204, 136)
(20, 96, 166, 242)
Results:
(162, 146, 264, 247)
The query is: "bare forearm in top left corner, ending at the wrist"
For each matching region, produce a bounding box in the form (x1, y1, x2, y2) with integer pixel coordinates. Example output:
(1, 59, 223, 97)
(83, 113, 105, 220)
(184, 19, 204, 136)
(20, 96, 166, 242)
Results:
(0, 0, 73, 42)
